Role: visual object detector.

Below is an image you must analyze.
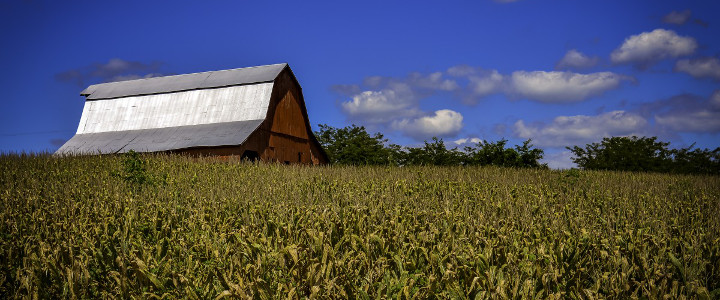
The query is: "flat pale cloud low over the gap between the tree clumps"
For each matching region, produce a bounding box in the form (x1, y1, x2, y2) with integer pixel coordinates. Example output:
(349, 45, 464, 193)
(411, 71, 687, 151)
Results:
(513, 110, 647, 147)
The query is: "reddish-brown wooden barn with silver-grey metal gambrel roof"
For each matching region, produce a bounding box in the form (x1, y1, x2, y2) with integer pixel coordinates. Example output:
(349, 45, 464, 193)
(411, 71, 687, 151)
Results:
(56, 64, 328, 164)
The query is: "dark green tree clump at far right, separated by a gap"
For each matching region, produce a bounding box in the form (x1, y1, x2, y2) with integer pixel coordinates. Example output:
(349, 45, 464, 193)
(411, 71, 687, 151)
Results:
(567, 136, 720, 174)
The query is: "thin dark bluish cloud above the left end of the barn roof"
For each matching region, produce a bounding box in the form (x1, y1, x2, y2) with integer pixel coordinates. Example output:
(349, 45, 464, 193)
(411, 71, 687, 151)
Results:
(55, 58, 162, 87)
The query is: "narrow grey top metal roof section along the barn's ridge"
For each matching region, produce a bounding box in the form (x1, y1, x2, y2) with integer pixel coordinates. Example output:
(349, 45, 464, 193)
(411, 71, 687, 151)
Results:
(80, 63, 287, 100)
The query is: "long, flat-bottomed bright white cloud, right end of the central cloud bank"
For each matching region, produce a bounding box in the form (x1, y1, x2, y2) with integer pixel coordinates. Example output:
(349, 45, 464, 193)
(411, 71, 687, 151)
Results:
(512, 71, 628, 103)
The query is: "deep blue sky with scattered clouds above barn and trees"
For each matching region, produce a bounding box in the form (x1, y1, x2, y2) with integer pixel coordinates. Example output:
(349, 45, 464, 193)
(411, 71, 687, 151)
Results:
(0, 0, 720, 168)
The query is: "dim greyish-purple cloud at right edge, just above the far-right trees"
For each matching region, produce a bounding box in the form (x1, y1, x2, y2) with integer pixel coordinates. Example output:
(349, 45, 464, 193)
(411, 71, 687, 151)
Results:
(640, 90, 720, 133)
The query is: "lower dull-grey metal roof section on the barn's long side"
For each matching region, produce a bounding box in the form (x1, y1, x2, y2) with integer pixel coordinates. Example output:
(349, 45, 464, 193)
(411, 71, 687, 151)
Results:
(55, 120, 263, 154)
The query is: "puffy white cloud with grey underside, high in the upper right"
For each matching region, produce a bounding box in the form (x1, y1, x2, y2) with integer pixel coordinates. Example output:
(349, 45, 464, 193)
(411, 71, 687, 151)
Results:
(610, 29, 698, 68)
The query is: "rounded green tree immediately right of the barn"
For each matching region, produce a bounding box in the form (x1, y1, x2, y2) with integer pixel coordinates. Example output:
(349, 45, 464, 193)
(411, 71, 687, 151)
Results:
(315, 124, 400, 165)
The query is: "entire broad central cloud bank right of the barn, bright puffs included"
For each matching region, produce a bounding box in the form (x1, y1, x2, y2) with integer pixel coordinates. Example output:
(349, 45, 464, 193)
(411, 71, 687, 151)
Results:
(331, 65, 632, 139)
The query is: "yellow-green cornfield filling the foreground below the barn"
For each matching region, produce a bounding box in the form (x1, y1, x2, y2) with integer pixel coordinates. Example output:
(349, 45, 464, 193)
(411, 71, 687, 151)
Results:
(0, 154, 720, 299)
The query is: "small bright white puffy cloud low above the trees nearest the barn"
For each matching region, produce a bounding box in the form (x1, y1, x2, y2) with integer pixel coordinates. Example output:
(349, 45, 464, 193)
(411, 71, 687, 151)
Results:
(392, 109, 463, 140)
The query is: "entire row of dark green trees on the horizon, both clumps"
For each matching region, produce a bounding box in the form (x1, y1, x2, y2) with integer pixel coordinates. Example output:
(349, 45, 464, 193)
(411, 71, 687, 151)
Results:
(315, 124, 720, 174)
